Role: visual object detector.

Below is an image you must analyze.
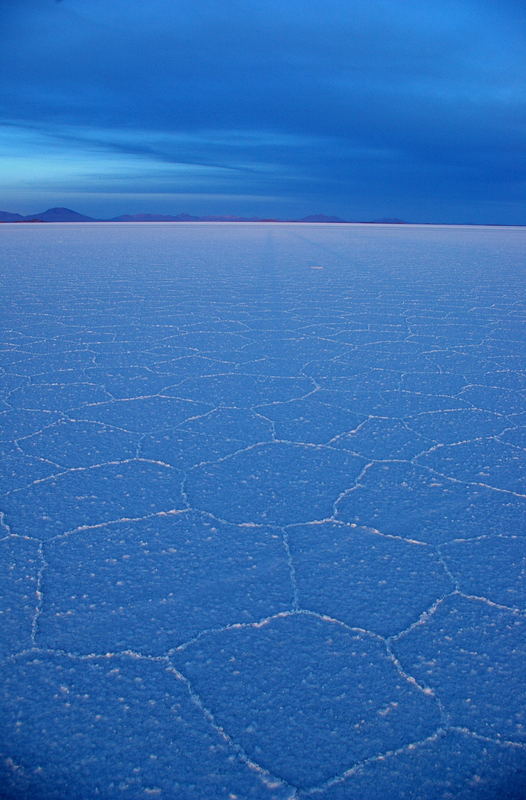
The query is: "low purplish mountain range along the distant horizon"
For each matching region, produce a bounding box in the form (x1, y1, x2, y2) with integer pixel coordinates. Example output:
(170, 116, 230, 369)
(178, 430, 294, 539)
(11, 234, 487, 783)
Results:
(0, 208, 405, 225)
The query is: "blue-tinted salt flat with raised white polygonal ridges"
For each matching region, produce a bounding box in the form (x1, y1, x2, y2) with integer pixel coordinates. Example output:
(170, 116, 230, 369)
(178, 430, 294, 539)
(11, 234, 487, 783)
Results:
(0, 224, 526, 800)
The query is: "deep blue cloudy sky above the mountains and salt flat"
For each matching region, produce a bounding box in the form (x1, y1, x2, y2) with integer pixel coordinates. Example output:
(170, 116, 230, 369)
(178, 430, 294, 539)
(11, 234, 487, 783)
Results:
(0, 0, 526, 225)
